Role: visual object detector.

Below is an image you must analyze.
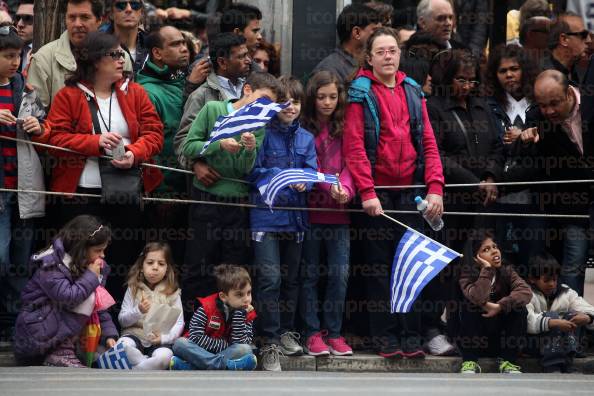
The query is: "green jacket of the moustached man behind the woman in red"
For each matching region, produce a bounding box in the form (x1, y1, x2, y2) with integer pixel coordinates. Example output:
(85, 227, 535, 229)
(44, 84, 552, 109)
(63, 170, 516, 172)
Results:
(136, 60, 186, 194)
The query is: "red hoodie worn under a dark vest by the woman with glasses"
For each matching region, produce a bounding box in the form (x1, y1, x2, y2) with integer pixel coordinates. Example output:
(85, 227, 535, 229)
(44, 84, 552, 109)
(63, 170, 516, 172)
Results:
(343, 69, 444, 201)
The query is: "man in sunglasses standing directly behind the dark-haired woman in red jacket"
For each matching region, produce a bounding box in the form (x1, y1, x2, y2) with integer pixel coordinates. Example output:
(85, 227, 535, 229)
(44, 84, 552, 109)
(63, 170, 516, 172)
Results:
(100, 0, 148, 73)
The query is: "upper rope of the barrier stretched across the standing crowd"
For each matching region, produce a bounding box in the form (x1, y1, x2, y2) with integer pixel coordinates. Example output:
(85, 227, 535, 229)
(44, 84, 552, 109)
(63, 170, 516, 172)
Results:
(0, 135, 594, 190)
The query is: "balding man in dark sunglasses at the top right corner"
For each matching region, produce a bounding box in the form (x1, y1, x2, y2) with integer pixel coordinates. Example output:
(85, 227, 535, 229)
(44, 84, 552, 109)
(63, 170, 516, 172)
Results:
(542, 13, 592, 87)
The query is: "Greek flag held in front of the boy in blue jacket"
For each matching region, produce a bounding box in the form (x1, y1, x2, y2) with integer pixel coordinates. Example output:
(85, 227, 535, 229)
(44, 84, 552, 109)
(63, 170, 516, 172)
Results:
(258, 169, 338, 207)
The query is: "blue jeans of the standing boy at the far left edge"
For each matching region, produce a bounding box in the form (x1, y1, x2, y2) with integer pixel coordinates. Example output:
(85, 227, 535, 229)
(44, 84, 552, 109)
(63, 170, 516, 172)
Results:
(0, 193, 34, 315)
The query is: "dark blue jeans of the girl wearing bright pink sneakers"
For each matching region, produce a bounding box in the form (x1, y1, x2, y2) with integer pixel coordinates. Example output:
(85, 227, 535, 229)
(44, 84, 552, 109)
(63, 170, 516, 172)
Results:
(299, 224, 350, 338)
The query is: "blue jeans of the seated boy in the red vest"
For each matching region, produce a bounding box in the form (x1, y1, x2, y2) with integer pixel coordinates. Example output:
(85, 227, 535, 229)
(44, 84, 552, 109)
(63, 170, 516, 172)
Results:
(173, 338, 252, 370)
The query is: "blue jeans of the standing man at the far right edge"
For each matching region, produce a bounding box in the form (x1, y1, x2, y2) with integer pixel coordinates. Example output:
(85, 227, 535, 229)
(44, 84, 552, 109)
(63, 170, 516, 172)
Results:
(561, 225, 588, 296)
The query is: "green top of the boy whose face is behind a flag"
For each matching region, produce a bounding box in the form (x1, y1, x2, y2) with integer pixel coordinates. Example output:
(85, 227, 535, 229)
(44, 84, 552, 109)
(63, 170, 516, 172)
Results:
(182, 100, 264, 197)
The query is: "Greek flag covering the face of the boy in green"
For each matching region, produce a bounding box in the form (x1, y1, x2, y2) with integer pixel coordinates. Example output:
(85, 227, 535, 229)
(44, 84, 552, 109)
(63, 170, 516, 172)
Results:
(200, 97, 289, 154)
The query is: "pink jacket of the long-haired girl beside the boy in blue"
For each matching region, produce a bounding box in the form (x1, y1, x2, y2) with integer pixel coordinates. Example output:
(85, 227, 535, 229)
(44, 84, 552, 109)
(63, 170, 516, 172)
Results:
(308, 126, 355, 224)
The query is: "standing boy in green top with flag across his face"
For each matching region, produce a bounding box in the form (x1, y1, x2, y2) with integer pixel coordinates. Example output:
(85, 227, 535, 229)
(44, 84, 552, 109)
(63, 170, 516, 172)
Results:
(181, 72, 279, 314)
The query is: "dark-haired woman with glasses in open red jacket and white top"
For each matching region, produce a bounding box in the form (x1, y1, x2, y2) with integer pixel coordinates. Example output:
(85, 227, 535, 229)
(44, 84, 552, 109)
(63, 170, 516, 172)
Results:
(47, 32, 163, 297)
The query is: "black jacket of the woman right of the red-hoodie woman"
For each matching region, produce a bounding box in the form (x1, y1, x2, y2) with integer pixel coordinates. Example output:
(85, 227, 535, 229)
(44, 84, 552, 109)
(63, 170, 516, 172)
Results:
(427, 96, 504, 183)
